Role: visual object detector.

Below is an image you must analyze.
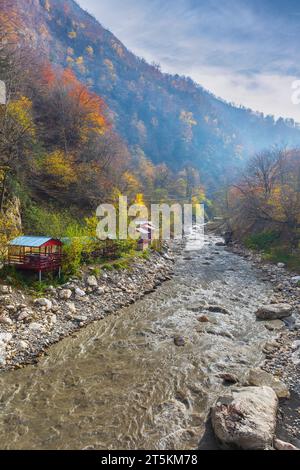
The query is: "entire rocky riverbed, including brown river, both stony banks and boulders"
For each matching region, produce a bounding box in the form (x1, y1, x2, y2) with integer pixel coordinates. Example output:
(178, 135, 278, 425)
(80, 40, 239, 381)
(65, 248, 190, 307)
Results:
(0, 235, 299, 450)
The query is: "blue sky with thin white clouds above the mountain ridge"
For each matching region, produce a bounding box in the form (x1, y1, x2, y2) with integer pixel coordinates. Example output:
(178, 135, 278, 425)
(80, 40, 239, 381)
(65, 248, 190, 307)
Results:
(77, 0, 300, 122)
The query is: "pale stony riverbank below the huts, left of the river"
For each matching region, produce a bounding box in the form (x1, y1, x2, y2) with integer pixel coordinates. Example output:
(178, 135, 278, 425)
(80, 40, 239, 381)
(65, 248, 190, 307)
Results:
(0, 248, 174, 371)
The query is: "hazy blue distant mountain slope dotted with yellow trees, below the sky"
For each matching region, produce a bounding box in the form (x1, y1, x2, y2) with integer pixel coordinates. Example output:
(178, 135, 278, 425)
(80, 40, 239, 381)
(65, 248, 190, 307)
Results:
(1, 0, 300, 185)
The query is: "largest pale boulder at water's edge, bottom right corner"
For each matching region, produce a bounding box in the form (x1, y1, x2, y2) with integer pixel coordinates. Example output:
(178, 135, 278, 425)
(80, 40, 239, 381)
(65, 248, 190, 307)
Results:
(212, 387, 278, 450)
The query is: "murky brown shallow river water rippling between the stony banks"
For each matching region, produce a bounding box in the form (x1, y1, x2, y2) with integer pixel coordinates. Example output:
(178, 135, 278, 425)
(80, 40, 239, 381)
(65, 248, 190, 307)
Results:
(0, 237, 272, 450)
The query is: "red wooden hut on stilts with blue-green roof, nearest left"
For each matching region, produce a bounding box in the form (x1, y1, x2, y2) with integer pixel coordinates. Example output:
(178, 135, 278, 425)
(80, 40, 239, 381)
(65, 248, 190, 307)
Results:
(7, 237, 63, 281)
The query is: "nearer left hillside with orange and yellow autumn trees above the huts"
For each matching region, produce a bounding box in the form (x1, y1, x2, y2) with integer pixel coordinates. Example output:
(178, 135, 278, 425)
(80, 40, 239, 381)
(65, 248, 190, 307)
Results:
(0, 7, 204, 260)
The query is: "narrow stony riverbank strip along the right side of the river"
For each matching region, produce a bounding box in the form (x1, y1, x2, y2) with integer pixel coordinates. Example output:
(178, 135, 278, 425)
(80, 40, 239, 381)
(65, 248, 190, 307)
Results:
(229, 244, 300, 448)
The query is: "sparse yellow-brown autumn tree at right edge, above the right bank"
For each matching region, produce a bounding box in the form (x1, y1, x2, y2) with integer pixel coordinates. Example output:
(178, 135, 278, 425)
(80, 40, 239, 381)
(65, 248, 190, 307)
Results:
(227, 149, 300, 246)
